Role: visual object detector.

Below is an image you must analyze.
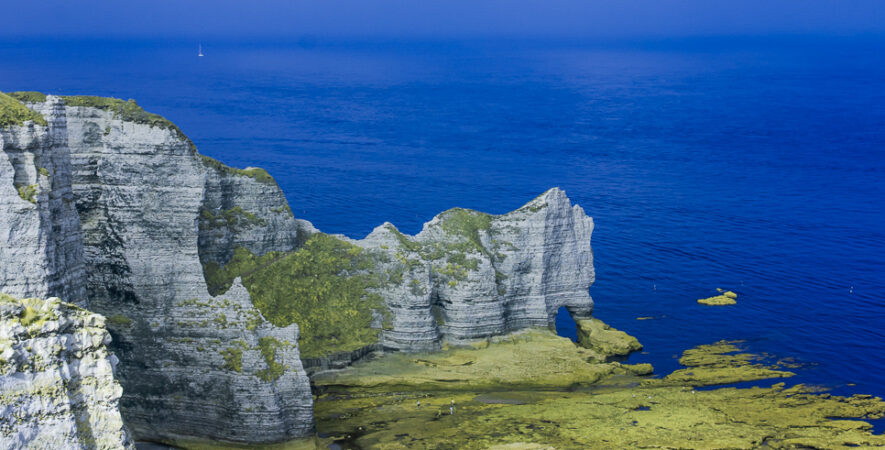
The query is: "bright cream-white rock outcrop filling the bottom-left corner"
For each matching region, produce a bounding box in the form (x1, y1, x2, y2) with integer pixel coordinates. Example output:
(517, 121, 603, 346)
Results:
(0, 294, 134, 449)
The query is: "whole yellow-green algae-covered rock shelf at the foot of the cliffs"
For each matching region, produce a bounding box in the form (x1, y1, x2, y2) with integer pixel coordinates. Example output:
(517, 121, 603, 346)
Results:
(315, 336, 885, 449)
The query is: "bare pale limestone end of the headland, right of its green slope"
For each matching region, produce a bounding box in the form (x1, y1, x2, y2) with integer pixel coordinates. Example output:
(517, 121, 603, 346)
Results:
(357, 188, 595, 351)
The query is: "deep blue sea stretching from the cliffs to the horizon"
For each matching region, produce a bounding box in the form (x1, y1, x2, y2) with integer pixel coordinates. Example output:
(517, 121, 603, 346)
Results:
(0, 38, 885, 395)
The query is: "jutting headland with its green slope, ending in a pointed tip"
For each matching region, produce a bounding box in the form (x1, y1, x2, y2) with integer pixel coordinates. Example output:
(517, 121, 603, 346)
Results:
(220, 189, 594, 372)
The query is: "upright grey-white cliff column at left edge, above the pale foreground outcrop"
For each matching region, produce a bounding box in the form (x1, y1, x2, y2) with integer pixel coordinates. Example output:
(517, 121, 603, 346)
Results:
(0, 98, 86, 305)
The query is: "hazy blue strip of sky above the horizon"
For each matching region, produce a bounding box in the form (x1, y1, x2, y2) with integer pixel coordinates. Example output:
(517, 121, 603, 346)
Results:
(0, 0, 885, 39)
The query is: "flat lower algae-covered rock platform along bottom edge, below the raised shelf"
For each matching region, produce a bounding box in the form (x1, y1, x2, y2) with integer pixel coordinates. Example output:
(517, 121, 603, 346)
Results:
(316, 384, 885, 449)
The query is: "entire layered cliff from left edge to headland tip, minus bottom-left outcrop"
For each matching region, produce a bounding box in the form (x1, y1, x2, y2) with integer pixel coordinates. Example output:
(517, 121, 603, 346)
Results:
(0, 94, 594, 442)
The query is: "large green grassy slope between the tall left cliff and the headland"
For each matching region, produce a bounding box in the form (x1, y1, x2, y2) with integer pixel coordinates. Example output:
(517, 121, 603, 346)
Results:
(203, 233, 387, 358)
